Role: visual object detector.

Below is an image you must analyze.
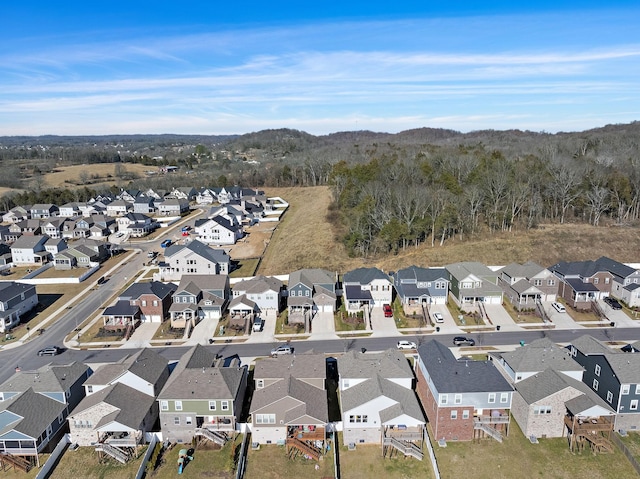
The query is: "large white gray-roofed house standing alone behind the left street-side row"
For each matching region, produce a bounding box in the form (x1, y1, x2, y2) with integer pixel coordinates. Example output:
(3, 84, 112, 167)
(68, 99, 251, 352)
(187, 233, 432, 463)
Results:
(159, 240, 231, 281)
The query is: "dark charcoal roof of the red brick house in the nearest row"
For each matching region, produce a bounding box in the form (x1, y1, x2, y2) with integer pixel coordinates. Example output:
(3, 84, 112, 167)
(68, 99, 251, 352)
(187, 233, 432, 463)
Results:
(418, 339, 513, 394)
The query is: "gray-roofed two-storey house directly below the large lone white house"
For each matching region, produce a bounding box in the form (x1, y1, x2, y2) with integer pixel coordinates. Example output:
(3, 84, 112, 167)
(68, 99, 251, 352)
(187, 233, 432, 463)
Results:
(169, 274, 230, 329)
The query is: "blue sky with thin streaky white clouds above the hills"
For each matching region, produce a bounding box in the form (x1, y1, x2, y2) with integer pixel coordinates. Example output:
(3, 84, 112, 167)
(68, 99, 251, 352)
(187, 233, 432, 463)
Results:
(0, 0, 640, 136)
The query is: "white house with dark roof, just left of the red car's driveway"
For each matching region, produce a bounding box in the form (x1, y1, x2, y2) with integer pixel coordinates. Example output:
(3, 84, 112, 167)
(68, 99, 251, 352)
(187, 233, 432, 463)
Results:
(342, 268, 393, 313)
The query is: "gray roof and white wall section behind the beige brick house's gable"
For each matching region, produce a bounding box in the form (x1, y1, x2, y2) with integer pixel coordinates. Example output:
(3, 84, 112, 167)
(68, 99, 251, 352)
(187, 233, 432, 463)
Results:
(489, 338, 584, 384)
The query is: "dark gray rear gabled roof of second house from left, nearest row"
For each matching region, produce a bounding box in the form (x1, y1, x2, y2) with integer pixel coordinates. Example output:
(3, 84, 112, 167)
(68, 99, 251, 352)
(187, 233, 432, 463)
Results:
(70, 383, 155, 430)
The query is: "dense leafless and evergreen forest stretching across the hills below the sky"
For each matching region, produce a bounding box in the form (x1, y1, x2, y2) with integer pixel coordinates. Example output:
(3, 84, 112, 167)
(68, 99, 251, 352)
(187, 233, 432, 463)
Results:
(0, 122, 640, 256)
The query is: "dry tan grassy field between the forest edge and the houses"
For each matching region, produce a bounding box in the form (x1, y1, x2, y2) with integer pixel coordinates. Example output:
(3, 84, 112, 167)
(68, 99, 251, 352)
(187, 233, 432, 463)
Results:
(259, 186, 640, 275)
